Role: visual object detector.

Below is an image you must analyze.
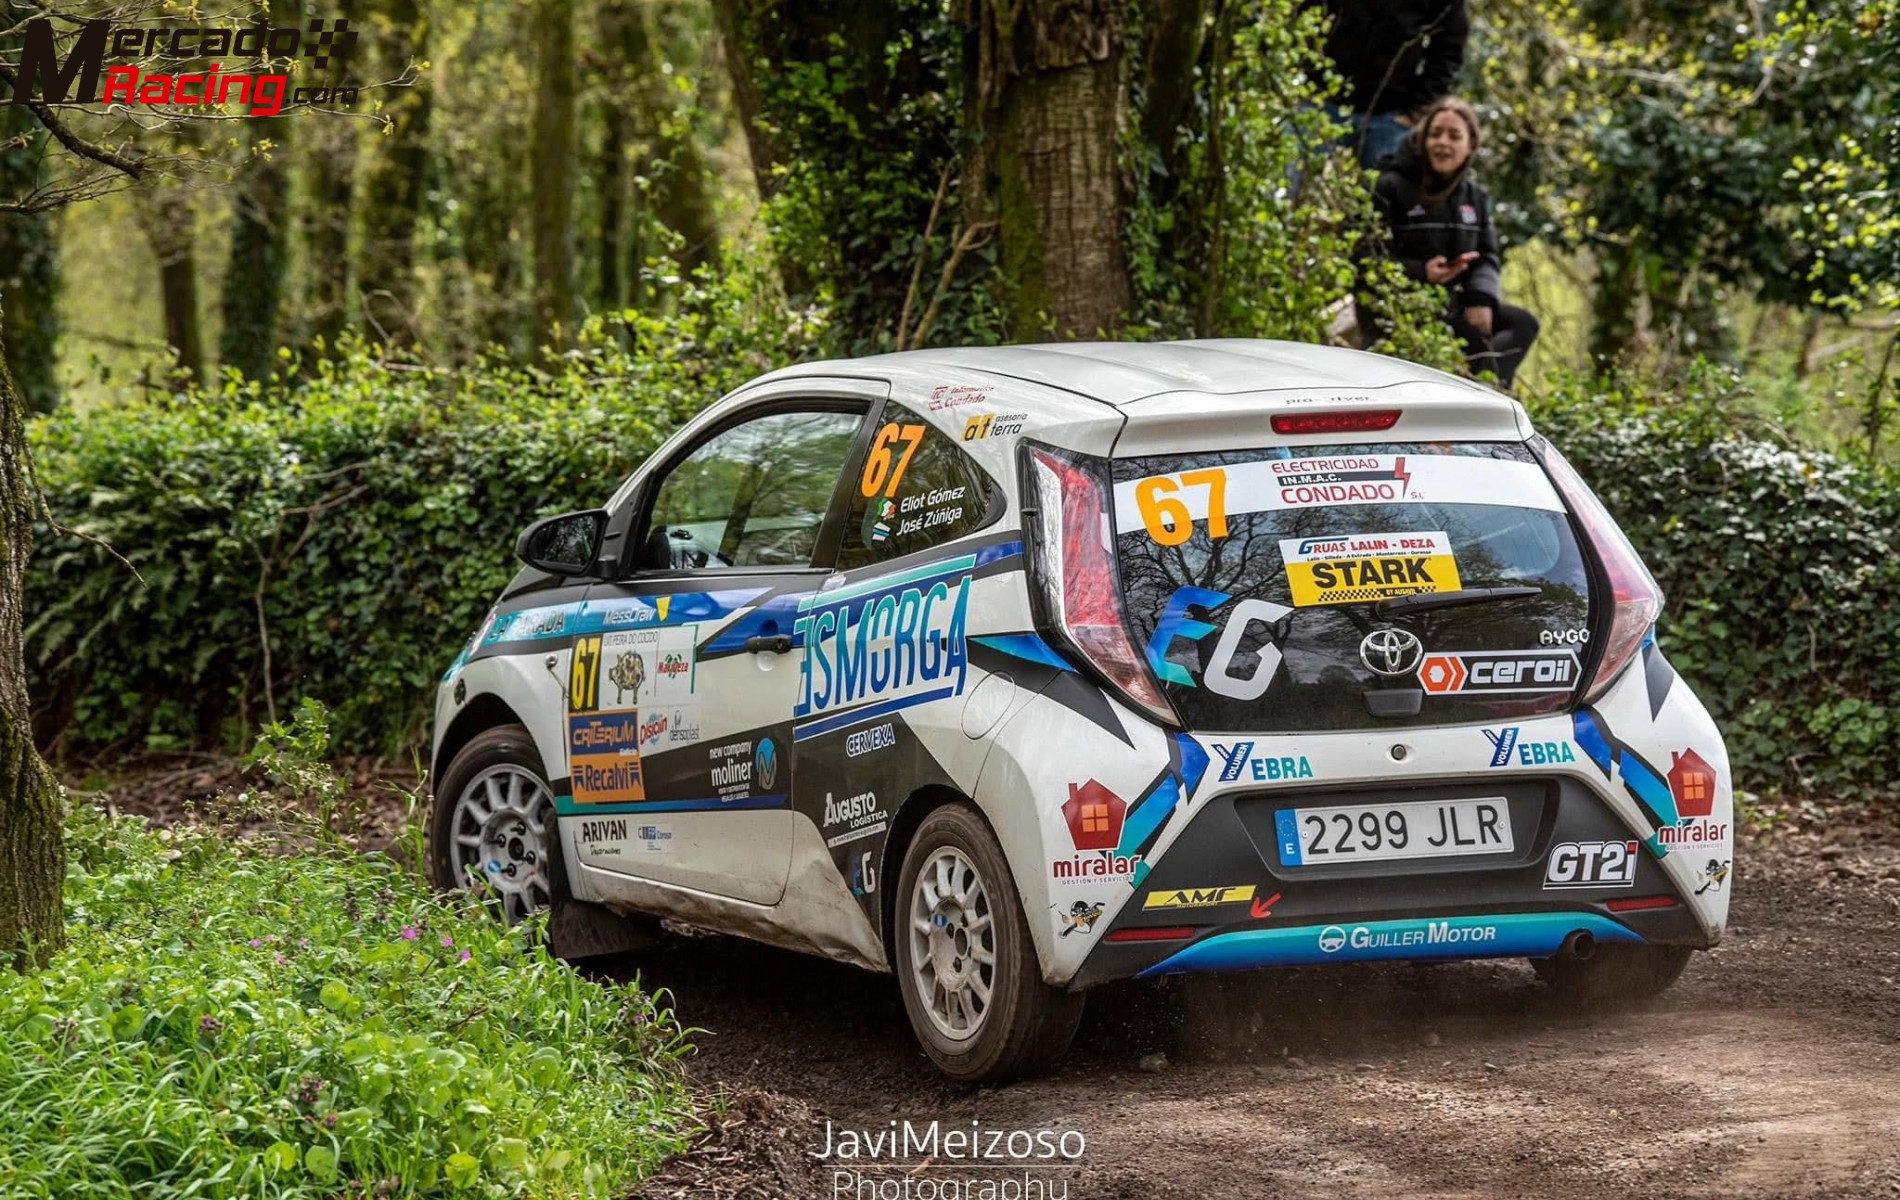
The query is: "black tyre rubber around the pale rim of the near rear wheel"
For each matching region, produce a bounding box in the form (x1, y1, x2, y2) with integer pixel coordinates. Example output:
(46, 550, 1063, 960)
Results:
(891, 803, 1083, 1082)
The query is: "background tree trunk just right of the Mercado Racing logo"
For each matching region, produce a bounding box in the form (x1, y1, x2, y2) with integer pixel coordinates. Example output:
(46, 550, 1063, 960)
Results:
(357, 0, 433, 346)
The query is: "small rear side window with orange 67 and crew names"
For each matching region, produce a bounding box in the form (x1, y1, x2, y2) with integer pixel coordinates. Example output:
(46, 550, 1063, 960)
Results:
(838, 404, 996, 570)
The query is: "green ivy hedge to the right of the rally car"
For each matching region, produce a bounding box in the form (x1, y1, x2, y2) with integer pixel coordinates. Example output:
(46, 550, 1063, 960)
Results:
(1533, 365, 1900, 797)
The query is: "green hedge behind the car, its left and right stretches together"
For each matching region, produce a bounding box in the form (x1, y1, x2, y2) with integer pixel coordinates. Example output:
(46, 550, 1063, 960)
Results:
(29, 341, 1900, 796)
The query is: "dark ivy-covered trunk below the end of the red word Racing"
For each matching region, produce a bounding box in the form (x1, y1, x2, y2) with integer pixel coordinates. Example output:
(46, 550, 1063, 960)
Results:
(219, 118, 291, 380)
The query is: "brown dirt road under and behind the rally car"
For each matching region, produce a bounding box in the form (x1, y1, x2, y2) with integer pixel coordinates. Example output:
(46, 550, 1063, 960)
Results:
(612, 820, 1900, 1200)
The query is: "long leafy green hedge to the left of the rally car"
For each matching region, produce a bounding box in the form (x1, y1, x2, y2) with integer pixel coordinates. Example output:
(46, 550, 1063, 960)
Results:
(27, 273, 819, 750)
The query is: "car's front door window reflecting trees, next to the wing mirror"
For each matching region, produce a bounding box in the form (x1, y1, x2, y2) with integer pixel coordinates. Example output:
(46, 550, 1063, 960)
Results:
(638, 412, 865, 572)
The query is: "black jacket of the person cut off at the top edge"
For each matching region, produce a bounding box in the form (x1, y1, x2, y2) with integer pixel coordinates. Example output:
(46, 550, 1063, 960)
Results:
(1305, 0, 1469, 112)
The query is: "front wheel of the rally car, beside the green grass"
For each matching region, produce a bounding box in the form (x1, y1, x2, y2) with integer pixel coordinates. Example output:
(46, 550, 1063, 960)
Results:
(429, 725, 555, 925)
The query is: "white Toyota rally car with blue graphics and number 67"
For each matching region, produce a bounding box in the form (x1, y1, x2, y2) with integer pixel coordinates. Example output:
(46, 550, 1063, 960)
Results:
(431, 340, 1733, 1078)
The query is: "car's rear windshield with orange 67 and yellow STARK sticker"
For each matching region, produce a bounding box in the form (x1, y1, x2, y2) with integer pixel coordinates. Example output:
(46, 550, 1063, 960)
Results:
(1113, 442, 1590, 733)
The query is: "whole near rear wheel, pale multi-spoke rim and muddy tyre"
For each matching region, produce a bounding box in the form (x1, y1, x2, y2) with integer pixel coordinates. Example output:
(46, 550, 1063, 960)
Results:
(893, 803, 1083, 1082)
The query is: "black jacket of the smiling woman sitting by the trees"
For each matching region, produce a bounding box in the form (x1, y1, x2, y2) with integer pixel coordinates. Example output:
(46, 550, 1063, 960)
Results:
(1372, 139, 1505, 308)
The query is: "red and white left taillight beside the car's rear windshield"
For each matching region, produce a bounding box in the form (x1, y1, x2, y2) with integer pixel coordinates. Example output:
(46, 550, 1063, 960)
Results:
(1026, 446, 1180, 725)
